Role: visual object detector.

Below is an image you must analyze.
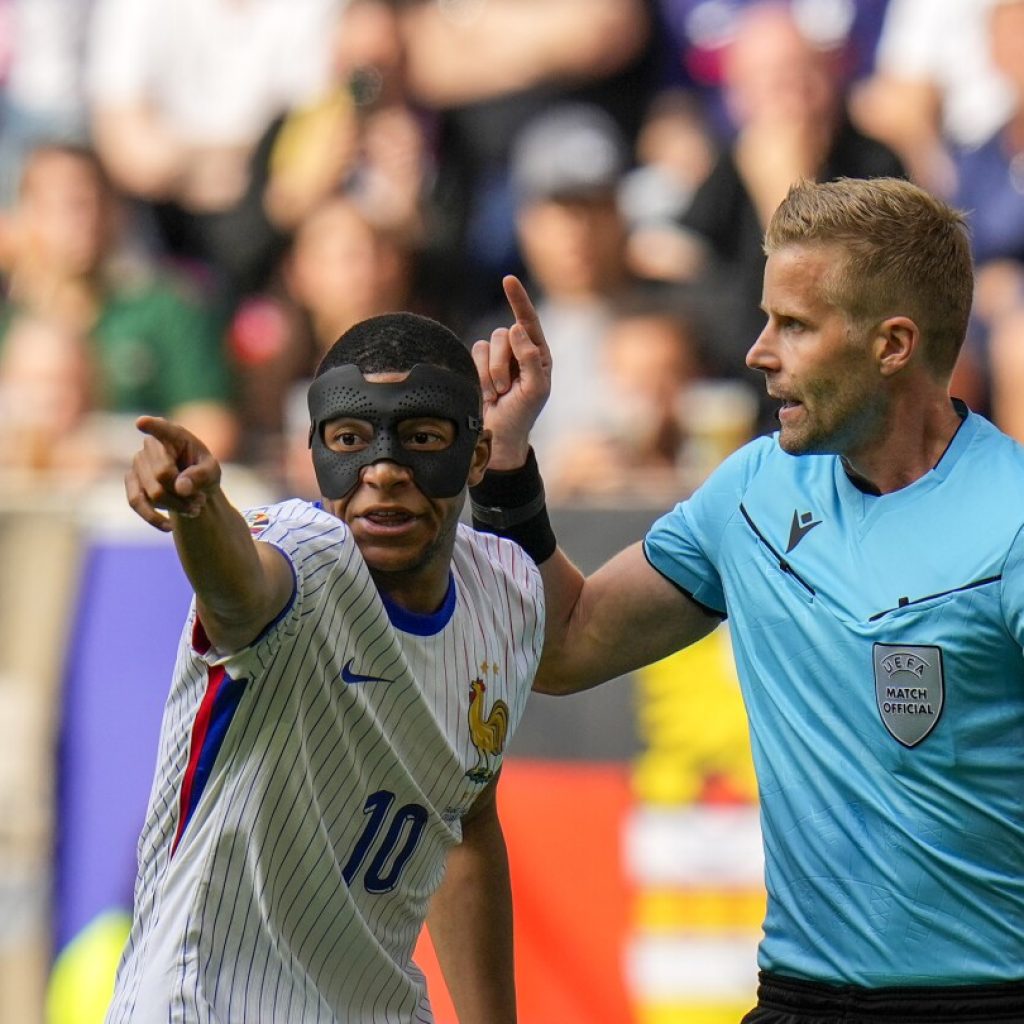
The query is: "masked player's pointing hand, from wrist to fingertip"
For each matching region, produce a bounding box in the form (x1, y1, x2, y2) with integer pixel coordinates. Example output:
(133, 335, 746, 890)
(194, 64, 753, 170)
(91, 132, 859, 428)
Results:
(125, 416, 220, 534)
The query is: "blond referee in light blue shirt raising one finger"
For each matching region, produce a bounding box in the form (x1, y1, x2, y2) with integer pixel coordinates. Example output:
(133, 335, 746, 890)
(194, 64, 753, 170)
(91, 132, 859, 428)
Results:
(471, 179, 1024, 1024)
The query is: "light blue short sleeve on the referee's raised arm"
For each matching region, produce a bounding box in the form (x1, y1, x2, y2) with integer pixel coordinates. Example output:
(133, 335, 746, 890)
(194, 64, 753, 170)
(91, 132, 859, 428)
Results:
(644, 437, 775, 615)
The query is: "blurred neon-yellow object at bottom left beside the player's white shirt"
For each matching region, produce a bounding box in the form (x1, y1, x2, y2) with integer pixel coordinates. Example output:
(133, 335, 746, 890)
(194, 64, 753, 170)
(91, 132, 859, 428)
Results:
(46, 910, 131, 1024)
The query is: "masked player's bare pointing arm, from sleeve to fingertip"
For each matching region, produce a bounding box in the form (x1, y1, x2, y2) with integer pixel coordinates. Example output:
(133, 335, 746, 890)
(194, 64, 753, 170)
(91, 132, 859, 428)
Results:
(125, 416, 293, 653)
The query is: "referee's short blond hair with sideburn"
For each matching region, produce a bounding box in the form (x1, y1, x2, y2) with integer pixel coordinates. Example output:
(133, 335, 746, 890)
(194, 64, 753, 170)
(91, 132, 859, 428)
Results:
(764, 178, 974, 375)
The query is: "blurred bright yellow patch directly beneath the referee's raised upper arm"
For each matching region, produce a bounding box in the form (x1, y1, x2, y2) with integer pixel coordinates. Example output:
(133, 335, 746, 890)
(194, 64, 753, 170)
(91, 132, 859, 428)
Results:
(633, 626, 757, 805)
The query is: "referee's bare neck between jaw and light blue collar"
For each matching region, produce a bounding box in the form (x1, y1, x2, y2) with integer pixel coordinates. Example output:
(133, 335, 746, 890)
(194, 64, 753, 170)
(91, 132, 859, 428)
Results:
(843, 393, 964, 495)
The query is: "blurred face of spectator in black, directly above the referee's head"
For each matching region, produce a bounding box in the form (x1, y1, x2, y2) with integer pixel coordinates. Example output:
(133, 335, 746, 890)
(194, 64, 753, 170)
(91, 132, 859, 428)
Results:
(725, 4, 838, 125)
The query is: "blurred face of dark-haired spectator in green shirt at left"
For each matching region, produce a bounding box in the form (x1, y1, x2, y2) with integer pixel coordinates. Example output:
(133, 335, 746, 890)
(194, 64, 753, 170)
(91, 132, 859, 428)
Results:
(15, 150, 113, 276)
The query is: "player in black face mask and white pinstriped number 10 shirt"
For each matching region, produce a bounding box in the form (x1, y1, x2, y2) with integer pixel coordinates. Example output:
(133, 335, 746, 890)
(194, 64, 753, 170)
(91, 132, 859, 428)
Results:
(109, 313, 544, 1024)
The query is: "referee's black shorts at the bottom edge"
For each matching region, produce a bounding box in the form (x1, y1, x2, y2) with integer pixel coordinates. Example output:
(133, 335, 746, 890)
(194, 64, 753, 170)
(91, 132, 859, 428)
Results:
(741, 971, 1024, 1024)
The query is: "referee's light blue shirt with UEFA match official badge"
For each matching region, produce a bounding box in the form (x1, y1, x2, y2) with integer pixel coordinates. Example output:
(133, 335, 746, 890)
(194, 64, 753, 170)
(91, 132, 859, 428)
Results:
(645, 409, 1024, 987)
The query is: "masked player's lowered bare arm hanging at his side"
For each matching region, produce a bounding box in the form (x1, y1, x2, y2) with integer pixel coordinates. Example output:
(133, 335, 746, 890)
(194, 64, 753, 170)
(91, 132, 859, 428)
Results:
(427, 778, 516, 1024)
